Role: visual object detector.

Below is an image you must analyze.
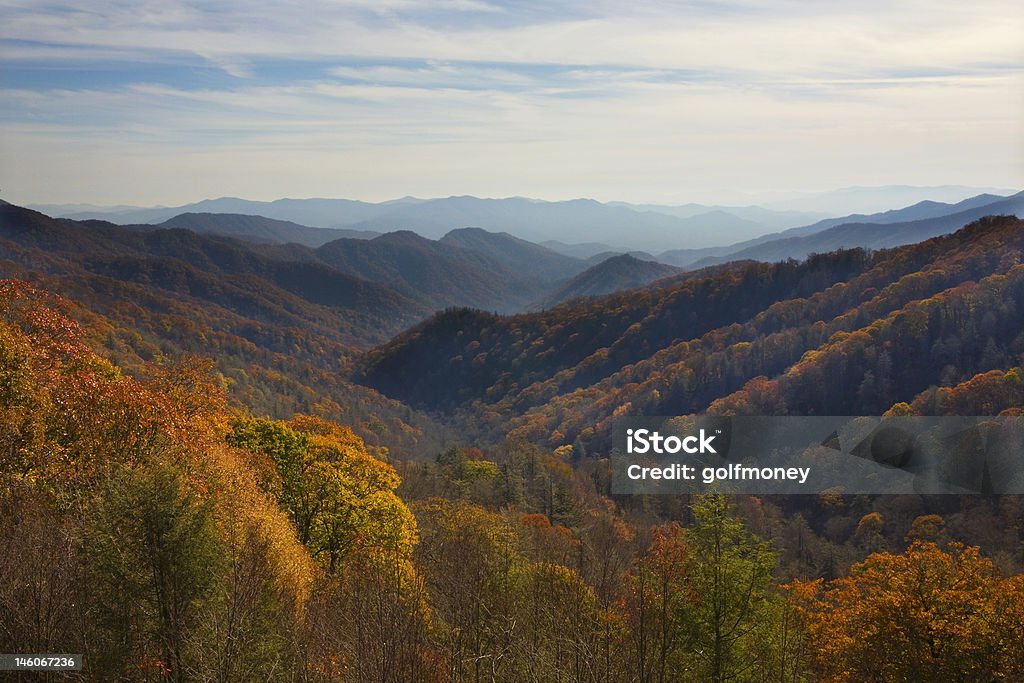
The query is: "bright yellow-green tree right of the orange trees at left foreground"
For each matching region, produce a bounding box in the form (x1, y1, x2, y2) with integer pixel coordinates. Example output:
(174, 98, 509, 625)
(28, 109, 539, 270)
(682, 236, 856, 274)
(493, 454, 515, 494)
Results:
(227, 416, 439, 682)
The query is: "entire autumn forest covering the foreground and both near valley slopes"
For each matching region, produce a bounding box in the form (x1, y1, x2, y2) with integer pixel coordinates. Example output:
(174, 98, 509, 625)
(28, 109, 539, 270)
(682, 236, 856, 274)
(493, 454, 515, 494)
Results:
(0, 206, 1024, 683)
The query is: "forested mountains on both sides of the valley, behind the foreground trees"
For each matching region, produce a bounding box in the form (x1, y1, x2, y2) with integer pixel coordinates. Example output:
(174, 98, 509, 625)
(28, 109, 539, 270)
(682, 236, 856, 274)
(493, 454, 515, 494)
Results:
(0, 195, 1024, 458)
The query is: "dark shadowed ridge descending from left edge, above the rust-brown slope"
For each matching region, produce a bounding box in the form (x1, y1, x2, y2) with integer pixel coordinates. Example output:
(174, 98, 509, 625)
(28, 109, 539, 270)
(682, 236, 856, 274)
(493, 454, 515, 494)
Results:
(0, 205, 430, 346)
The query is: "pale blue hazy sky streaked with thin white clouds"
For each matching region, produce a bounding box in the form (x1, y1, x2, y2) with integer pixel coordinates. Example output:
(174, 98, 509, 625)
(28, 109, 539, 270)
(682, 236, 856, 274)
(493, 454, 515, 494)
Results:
(0, 0, 1024, 205)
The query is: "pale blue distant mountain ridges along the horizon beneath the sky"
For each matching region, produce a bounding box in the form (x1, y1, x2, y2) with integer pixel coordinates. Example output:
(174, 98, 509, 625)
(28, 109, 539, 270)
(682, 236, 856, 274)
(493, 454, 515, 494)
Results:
(36, 186, 1015, 266)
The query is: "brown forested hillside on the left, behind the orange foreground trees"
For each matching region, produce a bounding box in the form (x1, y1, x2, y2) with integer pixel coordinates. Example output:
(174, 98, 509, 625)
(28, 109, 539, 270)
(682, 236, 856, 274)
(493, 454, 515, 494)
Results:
(0, 205, 442, 449)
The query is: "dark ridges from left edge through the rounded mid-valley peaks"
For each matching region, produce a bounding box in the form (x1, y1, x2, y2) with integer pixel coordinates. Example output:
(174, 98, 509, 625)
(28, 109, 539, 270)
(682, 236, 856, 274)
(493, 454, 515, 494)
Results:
(0, 205, 647, 323)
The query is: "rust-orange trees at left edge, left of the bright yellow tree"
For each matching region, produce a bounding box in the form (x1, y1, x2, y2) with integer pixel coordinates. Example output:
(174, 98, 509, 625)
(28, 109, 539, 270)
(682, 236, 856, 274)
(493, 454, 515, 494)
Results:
(0, 281, 312, 681)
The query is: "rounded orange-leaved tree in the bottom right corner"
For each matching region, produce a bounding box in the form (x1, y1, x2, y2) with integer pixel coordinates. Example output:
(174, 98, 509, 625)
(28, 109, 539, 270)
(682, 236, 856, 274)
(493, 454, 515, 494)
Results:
(790, 542, 1024, 681)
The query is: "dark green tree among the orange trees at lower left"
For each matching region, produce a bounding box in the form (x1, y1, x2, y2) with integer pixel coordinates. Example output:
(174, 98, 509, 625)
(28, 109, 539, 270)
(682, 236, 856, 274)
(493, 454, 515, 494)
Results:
(84, 463, 224, 681)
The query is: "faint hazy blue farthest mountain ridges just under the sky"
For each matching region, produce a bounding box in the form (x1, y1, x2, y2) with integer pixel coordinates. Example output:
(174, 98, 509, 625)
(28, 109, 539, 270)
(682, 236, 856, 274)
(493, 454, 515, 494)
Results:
(32, 186, 1015, 253)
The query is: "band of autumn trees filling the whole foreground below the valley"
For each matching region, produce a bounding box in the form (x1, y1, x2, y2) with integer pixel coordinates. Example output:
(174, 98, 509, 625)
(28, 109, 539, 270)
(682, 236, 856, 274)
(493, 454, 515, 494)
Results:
(0, 281, 1024, 683)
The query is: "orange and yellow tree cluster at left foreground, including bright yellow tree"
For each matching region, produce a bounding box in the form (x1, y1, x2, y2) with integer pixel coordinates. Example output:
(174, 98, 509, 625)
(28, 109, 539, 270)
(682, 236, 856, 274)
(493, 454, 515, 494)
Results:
(0, 282, 429, 681)
